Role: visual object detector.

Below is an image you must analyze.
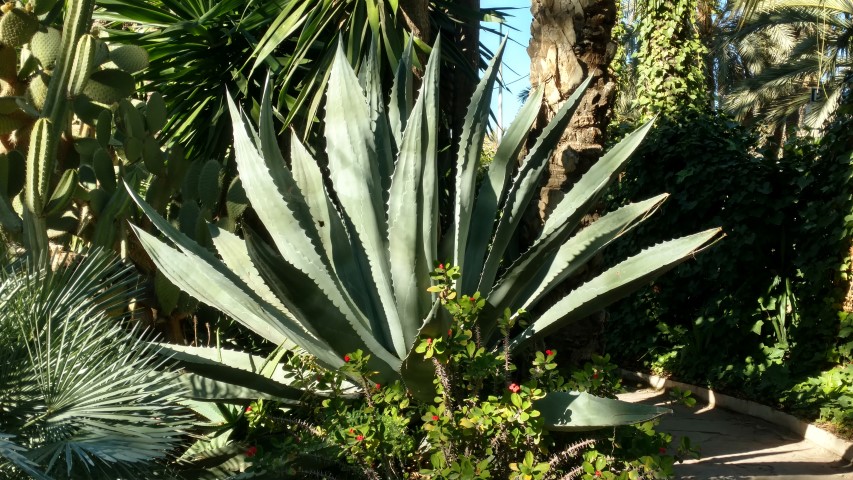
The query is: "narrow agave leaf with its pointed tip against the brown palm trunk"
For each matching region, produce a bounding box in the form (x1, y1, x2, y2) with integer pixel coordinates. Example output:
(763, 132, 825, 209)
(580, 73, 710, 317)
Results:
(477, 77, 592, 296)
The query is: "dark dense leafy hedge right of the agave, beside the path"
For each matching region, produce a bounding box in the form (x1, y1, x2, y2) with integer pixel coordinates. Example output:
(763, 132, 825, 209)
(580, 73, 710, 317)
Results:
(608, 111, 853, 432)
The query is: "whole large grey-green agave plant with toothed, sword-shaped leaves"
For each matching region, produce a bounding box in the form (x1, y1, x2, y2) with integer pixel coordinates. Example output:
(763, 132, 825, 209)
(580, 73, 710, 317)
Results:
(131, 39, 719, 430)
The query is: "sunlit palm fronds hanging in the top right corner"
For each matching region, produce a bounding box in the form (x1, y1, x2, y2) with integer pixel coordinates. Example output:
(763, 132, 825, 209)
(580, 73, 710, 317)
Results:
(725, 0, 853, 130)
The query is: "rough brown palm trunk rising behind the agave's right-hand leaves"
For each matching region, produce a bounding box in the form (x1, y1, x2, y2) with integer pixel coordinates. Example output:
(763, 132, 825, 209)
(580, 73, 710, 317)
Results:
(528, 0, 617, 361)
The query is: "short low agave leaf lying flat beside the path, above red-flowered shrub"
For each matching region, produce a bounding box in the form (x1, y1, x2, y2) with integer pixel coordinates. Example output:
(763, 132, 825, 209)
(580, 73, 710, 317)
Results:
(533, 392, 672, 432)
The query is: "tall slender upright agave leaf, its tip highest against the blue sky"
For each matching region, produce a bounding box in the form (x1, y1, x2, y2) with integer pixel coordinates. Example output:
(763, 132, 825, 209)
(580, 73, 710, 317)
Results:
(452, 38, 506, 294)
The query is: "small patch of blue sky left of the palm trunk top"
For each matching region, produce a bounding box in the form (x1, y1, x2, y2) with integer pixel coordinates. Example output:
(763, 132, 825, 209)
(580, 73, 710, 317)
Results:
(480, 0, 533, 128)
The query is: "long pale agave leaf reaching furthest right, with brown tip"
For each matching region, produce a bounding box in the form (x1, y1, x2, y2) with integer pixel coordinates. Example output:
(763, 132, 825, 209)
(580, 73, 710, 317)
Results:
(510, 228, 721, 350)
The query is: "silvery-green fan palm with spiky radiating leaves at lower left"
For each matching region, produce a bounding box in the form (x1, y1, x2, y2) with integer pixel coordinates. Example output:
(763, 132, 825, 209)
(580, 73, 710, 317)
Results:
(0, 252, 189, 479)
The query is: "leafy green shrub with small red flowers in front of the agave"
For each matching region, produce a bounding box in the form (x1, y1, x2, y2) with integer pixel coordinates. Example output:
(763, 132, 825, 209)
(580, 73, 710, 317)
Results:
(235, 264, 676, 480)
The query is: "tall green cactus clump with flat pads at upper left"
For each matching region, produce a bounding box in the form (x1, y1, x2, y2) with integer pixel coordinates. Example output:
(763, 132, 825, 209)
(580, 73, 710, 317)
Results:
(0, 0, 248, 338)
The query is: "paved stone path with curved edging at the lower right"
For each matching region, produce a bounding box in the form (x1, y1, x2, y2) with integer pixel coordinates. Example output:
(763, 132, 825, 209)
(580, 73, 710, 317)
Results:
(619, 389, 853, 480)
